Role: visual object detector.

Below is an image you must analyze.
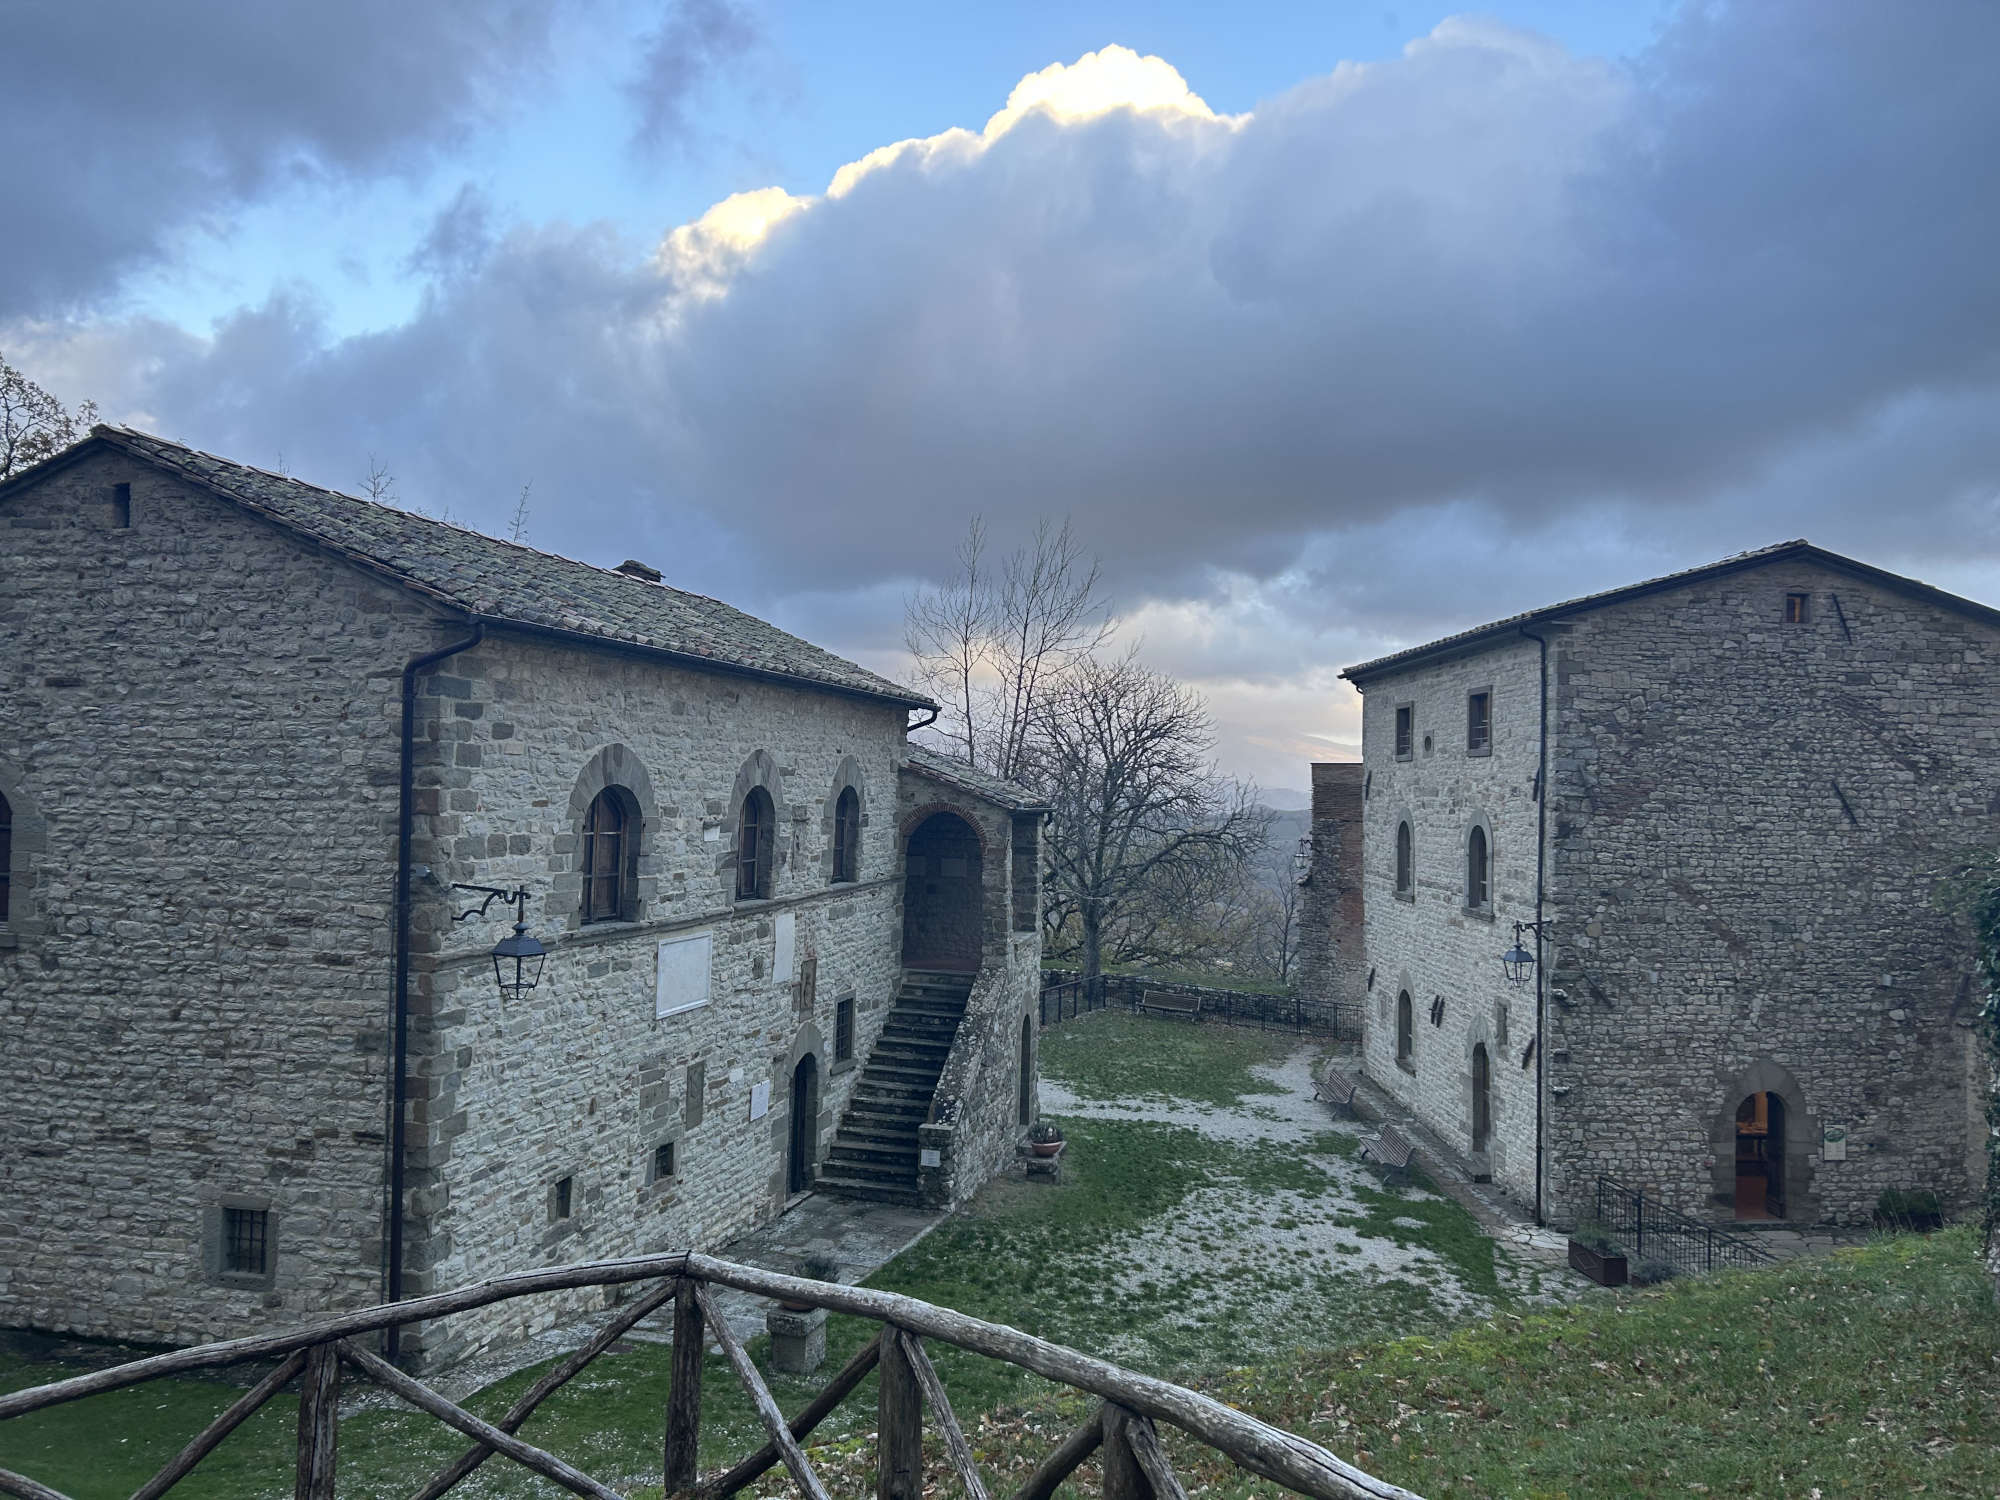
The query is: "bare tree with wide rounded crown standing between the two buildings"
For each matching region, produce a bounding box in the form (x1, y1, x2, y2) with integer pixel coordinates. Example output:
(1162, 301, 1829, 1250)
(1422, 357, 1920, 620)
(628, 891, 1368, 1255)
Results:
(1028, 652, 1268, 978)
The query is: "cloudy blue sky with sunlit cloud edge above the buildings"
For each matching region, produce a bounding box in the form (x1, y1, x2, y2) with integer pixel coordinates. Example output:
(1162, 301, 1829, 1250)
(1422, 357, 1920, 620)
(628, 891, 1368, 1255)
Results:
(0, 0, 2000, 804)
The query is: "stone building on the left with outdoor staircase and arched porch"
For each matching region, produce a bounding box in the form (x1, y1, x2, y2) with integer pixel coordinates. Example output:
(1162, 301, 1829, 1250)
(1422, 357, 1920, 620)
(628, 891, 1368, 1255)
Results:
(0, 428, 1044, 1362)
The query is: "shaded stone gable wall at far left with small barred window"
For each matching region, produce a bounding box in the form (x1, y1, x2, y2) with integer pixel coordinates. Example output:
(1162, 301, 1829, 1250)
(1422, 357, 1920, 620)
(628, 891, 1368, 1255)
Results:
(0, 454, 446, 1342)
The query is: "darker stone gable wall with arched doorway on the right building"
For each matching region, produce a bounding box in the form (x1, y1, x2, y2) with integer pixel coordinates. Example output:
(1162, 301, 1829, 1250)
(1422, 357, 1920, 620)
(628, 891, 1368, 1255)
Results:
(1548, 562, 2000, 1224)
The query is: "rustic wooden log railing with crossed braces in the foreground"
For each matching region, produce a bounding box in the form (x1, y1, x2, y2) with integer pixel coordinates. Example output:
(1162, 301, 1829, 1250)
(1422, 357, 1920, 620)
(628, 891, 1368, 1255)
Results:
(0, 1252, 1420, 1500)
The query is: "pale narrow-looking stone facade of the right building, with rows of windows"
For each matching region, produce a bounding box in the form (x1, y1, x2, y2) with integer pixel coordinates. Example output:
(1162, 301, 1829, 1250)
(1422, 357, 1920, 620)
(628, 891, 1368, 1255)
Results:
(1360, 640, 1540, 1202)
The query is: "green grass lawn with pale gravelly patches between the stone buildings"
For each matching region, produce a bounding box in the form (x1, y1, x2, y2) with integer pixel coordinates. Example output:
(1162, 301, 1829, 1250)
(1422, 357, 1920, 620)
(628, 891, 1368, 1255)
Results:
(0, 1014, 2000, 1500)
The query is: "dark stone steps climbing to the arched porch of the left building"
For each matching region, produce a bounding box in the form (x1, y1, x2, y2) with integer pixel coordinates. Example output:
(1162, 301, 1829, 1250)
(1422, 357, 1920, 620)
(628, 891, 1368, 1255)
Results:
(812, 968, 976, 1204)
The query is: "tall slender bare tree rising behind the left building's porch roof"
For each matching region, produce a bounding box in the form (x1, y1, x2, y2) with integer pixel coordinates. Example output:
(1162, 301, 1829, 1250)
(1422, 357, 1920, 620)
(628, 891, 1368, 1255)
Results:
(904, 516, 1110, 778)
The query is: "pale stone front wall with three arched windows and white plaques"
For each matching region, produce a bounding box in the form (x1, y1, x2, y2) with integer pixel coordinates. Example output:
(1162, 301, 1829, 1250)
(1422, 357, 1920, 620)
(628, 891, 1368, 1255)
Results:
(408, 636, 904, 1362)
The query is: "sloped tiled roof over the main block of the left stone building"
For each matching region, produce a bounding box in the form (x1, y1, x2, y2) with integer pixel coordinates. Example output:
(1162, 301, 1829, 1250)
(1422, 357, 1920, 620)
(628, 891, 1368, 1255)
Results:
(15, 426, 932, 708)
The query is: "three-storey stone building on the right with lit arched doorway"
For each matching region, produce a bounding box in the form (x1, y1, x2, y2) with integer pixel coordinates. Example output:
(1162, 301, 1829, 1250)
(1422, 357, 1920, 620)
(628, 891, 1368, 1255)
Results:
(1346, 542, 2000, 1224)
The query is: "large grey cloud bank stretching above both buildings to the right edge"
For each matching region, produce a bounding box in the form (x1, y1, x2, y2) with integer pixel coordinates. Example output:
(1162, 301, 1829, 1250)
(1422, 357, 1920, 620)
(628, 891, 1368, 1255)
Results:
(27, 0, 2000, 646)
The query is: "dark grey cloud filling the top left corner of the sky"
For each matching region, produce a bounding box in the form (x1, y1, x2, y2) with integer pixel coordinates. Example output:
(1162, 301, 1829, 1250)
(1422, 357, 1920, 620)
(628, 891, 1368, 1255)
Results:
(0, 0, 562, 316)
